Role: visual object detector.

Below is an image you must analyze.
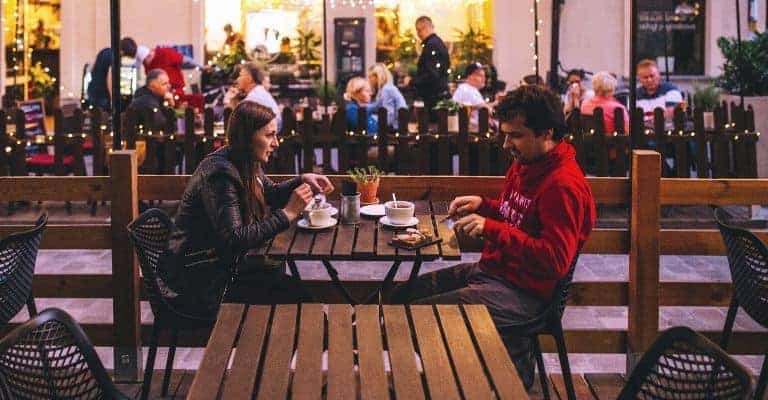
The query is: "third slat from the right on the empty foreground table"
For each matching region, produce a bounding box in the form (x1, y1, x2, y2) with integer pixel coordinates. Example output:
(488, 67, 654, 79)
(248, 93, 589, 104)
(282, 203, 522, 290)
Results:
(409, 305, 461, 399)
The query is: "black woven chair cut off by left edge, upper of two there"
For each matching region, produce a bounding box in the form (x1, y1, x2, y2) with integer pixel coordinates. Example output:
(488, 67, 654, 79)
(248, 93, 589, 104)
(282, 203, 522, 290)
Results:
(0, 213, 48, 325)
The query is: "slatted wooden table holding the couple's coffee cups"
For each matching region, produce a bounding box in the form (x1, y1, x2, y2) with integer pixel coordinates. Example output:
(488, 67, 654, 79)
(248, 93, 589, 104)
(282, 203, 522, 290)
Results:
(253, 201, 461, 304)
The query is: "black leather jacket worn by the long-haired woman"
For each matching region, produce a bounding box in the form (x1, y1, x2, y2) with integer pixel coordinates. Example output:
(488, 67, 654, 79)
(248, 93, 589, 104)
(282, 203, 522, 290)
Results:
(159, 146, 301, 313)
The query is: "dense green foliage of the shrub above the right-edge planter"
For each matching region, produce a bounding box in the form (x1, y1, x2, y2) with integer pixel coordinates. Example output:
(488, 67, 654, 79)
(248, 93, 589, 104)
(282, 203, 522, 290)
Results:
(716, 32, 768, 96)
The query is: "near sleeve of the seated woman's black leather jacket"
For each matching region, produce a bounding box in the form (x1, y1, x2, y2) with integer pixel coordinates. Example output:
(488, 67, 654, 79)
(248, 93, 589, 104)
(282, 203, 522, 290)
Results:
(201, 173, 290, 254)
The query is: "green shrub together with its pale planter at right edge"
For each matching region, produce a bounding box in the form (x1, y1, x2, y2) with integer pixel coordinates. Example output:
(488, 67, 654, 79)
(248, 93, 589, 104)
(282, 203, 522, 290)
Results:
(716, 32, 768, 178)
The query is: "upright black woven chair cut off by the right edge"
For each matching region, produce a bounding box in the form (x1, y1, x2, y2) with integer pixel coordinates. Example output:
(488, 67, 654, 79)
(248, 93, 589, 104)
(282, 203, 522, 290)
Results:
(715, 208, 768, 399)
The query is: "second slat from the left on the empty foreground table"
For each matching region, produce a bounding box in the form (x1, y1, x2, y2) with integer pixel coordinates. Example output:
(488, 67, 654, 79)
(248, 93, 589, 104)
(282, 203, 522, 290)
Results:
(221, 305, 271, 400)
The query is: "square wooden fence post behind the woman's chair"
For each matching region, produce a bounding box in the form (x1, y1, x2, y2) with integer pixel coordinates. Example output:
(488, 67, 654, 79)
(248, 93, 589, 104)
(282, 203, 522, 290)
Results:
(110, 150, 141, 382)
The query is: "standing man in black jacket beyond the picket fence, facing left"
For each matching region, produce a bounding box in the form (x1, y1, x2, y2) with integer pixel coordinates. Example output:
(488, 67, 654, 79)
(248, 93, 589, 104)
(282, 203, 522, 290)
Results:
(410, 16, 451, 121)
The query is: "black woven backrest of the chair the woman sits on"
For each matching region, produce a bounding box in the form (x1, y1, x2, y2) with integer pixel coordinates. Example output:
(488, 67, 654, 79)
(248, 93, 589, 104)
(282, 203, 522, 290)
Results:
(128, 208, 173, 318)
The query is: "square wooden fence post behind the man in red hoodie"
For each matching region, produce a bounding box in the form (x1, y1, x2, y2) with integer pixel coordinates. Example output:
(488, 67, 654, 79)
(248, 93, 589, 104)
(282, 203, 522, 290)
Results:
(627, 150, 662, 374)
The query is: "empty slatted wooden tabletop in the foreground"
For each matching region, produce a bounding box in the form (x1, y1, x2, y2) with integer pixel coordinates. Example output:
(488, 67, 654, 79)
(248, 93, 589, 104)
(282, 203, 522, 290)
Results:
(187, 304, 528, 400)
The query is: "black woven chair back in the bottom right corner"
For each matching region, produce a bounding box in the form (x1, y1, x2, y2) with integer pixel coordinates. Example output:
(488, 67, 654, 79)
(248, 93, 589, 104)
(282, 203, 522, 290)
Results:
(618, 326, 751, 400)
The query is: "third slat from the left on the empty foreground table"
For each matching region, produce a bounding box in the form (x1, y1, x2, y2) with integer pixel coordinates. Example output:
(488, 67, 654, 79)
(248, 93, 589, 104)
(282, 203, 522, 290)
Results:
(256, 304, 296, 400)
